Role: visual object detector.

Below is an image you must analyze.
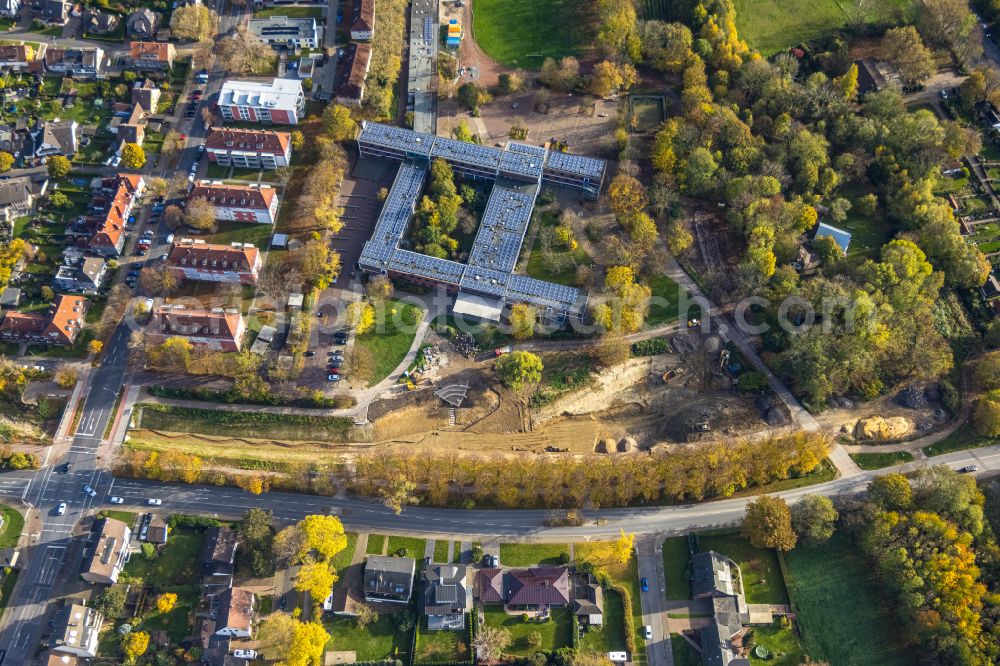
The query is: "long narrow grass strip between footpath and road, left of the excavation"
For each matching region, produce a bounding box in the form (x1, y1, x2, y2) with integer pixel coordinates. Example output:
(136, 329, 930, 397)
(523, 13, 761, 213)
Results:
(140, 404, 354, 442)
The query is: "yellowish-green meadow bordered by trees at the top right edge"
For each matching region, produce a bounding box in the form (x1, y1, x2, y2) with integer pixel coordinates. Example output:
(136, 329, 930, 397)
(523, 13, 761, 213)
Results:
(734, 0, 909, 55)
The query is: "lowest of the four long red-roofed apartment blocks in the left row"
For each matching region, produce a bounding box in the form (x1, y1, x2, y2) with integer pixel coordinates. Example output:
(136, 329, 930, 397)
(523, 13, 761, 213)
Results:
(146, 305, 246, 352)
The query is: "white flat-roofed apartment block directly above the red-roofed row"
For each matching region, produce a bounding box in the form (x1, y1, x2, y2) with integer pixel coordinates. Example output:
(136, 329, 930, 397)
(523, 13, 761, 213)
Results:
(218, 79, 306, 125)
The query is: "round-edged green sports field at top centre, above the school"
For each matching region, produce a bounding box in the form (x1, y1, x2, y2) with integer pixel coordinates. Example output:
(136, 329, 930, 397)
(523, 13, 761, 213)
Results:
(472, 0, 589, 69)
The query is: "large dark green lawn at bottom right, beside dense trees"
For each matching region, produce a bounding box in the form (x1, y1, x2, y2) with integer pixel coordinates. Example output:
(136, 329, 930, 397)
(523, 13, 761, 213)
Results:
(784, 532, 919, 666)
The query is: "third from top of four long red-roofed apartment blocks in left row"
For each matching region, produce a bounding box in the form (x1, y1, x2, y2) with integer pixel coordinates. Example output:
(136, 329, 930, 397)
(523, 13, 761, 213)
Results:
(167, 238, 263, 284)
